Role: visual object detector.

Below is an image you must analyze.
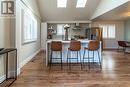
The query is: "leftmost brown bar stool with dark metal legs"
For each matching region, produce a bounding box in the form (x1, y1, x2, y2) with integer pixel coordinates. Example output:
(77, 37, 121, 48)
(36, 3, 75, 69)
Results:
(50, 41, 62, 69)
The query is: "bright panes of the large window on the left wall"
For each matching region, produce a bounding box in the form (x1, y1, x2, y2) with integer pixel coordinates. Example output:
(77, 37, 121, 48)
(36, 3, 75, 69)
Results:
(22, 10, 37, 43)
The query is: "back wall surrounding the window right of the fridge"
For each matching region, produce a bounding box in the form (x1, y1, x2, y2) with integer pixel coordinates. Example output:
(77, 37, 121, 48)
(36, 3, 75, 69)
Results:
(92, 21, 124, 49)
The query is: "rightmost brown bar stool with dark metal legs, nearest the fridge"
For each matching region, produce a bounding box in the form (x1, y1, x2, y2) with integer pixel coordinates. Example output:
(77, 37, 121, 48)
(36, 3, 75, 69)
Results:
(83, 40, 102, 70)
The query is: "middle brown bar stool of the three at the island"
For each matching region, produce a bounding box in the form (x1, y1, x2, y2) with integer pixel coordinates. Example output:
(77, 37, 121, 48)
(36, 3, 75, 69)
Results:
(67, 41, 82, 69)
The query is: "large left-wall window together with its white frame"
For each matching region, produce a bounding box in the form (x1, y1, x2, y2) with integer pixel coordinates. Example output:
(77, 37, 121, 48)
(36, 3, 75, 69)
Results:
(22, 9, 38, 45)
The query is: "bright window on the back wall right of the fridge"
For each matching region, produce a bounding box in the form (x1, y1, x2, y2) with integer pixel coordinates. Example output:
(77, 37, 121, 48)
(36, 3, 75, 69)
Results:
(100, 25, 116, 39)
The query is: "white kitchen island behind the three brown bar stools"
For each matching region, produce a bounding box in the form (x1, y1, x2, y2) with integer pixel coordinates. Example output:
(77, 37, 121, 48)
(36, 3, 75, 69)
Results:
(46, 39, 102, 65)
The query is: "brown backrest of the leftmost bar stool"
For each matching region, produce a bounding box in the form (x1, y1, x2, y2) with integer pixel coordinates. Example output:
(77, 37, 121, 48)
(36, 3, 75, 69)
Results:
(51, 41, 62, 51)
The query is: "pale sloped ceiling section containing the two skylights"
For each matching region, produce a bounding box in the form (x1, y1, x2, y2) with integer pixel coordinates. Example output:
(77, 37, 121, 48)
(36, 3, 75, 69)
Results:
(37, 0, 100, 21)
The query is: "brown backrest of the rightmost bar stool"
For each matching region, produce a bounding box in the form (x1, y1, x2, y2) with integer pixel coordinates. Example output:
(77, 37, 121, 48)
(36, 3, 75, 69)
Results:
(88, 40, 99, 51)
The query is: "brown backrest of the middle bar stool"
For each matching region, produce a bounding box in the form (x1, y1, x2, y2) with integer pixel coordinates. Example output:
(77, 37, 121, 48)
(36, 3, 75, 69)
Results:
(69, 41, 81, 51)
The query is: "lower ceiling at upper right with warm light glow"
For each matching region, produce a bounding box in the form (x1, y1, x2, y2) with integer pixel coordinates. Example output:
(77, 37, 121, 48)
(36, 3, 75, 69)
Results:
(94, 2, 130, 21)
